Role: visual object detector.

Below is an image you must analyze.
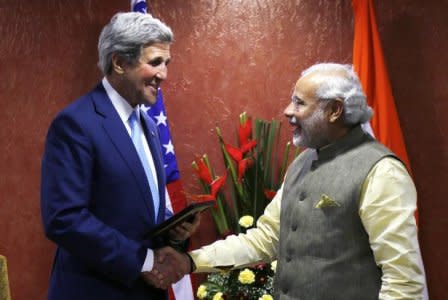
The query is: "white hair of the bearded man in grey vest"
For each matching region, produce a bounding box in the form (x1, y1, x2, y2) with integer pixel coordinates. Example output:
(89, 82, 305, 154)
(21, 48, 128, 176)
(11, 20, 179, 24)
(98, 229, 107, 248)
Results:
(301, 63, 373, 125)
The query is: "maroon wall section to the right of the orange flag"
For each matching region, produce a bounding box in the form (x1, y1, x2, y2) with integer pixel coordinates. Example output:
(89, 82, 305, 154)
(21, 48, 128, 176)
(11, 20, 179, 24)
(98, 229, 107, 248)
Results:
(377, 0, 448, 299)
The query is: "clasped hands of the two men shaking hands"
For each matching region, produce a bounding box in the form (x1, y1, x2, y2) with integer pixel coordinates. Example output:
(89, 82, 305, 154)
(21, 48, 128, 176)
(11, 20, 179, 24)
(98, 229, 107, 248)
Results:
(142, 247, 193, 290)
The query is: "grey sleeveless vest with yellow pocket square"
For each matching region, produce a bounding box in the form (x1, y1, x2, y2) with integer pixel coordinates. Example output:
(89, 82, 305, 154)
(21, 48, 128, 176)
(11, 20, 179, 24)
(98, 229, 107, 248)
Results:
(275, 126, 395, 300)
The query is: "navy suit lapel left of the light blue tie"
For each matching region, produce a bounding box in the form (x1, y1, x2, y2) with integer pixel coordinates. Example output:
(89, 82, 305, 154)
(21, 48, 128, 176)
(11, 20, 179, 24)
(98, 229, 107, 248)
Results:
(92, 84, 154, 222)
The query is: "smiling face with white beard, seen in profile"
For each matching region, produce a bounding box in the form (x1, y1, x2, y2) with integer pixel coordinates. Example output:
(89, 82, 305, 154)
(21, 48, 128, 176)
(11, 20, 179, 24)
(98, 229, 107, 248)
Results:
(284, 74, 329, 149)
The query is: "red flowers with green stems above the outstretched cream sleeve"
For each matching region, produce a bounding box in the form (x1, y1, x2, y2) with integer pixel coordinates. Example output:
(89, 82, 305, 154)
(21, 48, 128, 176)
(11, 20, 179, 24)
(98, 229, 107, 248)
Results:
(192, 112, 297, 236)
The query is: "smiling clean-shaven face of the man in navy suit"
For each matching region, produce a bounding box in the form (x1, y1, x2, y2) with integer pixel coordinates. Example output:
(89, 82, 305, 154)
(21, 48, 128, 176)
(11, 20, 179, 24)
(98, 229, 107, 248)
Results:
(113, 43, 171, 107)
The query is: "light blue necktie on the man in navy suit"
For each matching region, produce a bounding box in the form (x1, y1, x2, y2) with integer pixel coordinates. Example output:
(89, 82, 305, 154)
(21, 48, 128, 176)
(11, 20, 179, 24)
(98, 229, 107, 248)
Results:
(129, 108, 160, 219)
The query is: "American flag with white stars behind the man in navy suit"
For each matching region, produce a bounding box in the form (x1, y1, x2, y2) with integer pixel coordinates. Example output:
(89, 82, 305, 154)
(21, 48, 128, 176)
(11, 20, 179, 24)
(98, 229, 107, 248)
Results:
(131, 0, 194, 300)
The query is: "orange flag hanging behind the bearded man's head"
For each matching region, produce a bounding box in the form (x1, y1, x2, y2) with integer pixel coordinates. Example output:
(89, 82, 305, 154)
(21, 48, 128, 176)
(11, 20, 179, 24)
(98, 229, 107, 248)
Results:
(352, 0, 410, 170)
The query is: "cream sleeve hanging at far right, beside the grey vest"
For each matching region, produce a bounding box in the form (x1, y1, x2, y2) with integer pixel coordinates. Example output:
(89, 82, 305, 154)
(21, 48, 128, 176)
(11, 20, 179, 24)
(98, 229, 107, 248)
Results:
(359, 158, 426, 300)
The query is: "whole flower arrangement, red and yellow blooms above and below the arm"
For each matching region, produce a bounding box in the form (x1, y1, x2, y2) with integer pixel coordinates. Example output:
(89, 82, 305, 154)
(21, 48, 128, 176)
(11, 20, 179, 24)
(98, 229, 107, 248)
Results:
(192, 113, 298, 300)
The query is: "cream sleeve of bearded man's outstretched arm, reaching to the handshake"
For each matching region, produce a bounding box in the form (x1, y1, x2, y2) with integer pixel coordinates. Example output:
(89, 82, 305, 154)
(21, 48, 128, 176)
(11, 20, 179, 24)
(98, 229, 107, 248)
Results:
(190, 186, 283, 272)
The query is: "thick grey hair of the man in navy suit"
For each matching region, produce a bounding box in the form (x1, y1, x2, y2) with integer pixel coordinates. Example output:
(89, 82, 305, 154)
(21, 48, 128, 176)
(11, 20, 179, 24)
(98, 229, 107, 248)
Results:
(98, 12, 174, 75)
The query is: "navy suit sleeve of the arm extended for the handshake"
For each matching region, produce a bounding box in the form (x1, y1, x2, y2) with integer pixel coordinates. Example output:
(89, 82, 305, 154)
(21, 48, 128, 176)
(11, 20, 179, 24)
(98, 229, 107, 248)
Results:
(41, 115, 147, 285)
